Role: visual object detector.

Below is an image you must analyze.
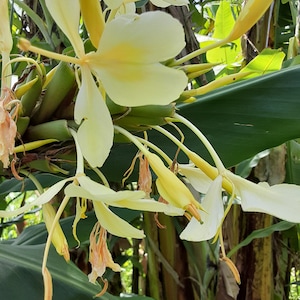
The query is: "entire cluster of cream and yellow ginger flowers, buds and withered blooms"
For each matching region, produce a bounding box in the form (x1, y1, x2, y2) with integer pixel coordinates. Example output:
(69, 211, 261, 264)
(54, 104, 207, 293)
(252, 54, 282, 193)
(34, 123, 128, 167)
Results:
(0, 0, 300, 299)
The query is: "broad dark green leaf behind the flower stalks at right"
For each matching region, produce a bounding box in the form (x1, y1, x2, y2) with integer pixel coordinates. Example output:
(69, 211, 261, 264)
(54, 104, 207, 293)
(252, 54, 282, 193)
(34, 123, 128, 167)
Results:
(104, 66, 300, 180)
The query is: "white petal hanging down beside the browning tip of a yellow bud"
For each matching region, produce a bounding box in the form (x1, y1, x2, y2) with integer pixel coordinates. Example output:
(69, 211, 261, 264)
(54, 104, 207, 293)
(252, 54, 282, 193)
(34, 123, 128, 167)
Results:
(180, 175, 224, 242)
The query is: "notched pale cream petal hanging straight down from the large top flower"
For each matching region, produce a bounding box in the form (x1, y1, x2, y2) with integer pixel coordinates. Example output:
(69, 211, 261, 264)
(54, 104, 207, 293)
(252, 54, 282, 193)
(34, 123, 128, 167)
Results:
(74, 67, 114, 167)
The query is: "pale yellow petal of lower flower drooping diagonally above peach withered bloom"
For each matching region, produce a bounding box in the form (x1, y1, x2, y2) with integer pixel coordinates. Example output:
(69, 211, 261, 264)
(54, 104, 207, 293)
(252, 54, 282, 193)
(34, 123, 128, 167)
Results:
(93, 201, 144, 239)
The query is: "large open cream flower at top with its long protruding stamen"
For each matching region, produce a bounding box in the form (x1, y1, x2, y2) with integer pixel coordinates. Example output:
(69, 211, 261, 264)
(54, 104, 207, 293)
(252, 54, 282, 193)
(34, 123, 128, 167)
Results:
(19, 0, 187, 167)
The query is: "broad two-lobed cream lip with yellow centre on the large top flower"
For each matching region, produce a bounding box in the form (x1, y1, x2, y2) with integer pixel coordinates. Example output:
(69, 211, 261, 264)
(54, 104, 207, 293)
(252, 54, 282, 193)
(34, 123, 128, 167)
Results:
(86, 11, 187, 106)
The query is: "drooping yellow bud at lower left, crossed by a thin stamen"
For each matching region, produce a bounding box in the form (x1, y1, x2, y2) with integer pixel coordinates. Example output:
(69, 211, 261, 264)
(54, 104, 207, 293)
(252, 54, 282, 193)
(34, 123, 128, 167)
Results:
(42, 203, 70, 261)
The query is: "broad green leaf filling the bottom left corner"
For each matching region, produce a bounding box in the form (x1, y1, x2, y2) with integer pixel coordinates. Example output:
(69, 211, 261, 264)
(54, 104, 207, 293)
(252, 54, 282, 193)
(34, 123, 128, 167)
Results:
(0, 244, 110, 300)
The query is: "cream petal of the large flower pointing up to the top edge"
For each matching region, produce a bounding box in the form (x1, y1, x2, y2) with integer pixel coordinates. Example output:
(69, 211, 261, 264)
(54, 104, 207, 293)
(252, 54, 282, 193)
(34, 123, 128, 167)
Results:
(46, 0, 84, 57)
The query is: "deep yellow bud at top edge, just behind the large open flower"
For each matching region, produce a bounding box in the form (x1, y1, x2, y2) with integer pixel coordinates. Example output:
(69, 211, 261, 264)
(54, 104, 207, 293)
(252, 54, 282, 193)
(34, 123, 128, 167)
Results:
(80, 0, 105, 48)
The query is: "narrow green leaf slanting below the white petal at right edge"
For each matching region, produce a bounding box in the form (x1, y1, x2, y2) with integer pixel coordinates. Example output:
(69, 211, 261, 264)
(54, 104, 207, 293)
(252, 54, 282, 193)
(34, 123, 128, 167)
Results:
(227, 221, 296, 258)
